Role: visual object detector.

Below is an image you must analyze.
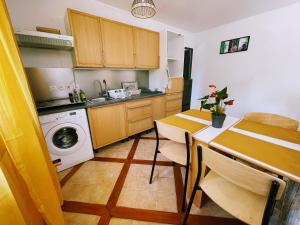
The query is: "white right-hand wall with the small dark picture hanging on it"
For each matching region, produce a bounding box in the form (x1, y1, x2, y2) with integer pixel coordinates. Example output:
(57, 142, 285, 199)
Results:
(192, 4, 300, 120)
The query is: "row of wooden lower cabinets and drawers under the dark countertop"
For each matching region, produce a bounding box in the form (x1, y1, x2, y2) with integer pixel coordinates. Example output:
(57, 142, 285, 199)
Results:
(88, 93, 182, 149)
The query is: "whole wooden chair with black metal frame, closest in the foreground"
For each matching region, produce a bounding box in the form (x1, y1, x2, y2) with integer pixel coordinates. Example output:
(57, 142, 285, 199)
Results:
(183, 146, 286, 225)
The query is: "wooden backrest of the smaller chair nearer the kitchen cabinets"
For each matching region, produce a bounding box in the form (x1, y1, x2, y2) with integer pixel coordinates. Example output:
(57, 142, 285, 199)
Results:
(155, 121, 192, 144)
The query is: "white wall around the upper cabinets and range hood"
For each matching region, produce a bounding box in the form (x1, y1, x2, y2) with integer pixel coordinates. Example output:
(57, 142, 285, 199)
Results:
(6, 0, 192, 92)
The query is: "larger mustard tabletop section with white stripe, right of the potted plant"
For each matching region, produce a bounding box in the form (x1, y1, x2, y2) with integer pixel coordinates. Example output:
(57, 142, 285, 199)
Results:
(209, 120, 300, 183)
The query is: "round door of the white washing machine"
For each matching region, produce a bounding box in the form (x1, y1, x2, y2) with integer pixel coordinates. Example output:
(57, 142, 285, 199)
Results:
(46, 123, 86, 155)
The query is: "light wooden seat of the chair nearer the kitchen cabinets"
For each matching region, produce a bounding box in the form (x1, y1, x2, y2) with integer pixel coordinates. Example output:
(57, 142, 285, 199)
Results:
(159, 141, 186, 165)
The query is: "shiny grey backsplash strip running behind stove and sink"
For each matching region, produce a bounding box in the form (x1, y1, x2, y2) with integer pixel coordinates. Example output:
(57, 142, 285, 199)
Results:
(26, 68, 149, 102)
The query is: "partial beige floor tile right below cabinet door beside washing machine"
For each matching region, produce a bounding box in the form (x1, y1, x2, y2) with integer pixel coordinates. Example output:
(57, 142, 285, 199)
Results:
(95, 139, 134, 159)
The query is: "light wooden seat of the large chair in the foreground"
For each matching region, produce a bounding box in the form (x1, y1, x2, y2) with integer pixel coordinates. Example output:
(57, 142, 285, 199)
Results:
(200, 171, 267, 225)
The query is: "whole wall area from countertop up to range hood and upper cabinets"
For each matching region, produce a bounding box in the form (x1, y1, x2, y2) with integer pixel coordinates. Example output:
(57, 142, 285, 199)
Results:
(20, 48, 149, 101)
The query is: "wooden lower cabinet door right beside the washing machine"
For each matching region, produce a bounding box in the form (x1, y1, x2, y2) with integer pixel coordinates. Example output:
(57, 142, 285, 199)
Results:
(88, 104, 126, 149)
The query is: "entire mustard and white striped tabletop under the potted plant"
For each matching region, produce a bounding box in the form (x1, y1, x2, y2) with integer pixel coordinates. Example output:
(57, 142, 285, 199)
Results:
(160, 110, 300, 183)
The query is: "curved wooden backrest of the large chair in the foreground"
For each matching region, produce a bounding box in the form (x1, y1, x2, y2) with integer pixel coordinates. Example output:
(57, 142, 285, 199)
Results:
(202, 147, 286, 199)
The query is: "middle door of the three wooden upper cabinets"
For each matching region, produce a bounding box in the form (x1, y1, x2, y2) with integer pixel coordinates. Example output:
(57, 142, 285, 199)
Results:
(101, 19, 134, 68)
